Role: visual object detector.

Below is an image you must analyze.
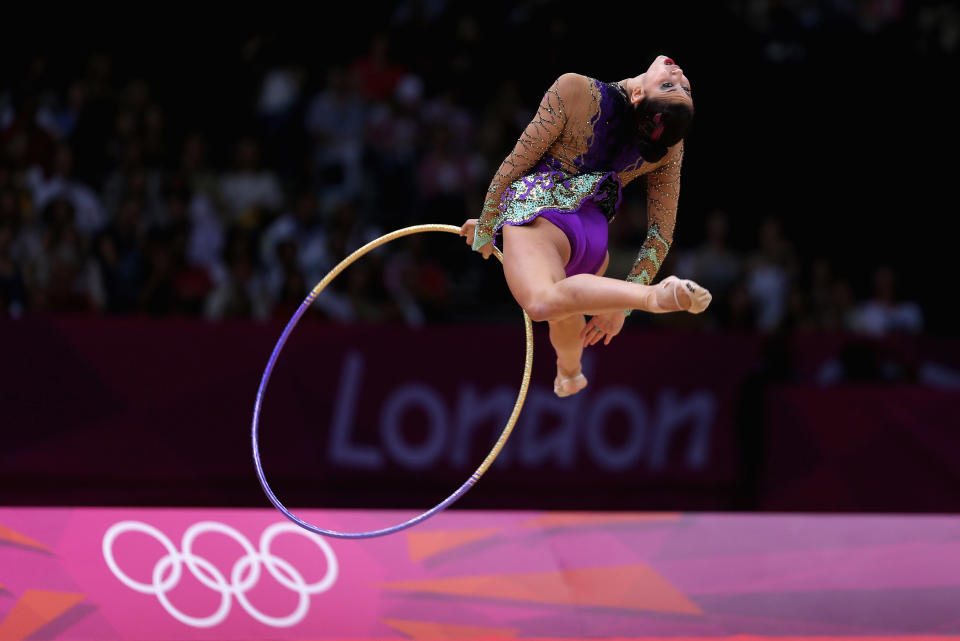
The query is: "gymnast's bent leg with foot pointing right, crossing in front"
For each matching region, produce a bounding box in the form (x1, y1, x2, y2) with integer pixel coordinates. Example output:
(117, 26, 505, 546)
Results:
(503, 218, 705, 321)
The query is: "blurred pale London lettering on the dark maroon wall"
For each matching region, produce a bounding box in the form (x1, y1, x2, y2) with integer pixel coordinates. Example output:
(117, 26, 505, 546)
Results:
(328, 351, 717, 472)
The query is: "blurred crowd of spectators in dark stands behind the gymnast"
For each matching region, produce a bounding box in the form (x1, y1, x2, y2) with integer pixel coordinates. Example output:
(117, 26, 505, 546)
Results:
(0, 2, 960, 335)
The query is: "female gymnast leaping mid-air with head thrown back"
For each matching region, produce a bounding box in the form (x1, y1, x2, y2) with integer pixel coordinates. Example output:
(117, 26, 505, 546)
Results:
(460, 56, 711, 396)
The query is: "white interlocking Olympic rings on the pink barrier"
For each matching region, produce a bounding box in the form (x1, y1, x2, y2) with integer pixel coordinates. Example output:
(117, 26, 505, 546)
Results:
(103, 521, 339, 628)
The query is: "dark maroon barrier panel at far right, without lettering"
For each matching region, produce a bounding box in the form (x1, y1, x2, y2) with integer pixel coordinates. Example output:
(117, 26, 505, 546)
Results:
(763, 385, 960, 512)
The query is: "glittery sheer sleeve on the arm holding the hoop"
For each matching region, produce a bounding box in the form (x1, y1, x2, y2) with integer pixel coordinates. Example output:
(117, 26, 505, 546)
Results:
(473, 73, 572, 250)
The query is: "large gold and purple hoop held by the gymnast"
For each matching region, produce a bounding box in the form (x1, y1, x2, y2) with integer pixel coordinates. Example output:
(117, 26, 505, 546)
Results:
(251, 225, 533, 539)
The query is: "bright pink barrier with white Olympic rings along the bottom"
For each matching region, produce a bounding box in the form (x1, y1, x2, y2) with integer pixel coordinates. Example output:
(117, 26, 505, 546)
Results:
(0, 508, 960, 641)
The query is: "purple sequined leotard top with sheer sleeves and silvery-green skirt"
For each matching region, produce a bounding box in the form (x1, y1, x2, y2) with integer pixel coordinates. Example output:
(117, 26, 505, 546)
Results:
(473, 73, 683, 285)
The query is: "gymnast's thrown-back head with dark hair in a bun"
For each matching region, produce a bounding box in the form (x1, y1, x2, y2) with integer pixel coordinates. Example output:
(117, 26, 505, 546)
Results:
(624, 56, 693, 162)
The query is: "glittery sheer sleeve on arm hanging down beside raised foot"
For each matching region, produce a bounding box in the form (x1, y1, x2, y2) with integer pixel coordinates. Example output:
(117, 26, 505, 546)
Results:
(627, 143, 683, 285)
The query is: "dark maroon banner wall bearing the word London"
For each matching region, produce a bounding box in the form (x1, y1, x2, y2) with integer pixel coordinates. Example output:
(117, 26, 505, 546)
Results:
(0, 318, 759, 505)
